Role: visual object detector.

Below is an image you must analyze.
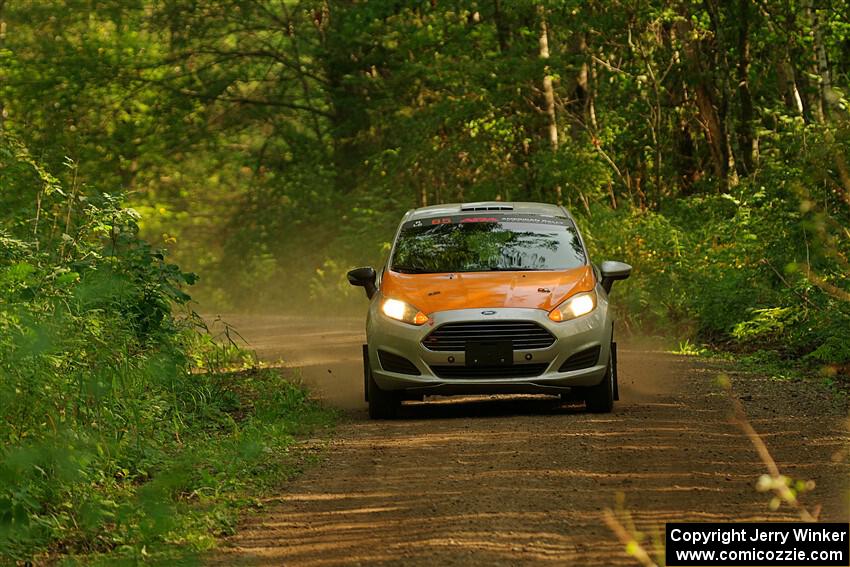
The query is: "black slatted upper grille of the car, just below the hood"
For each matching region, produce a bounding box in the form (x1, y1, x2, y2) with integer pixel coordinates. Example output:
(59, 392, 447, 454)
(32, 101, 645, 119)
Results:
(422, 321, 555, 351)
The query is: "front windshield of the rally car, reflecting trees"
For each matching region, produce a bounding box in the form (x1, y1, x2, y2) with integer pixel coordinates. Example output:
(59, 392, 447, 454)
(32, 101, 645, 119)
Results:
(390, 215, 586, 274)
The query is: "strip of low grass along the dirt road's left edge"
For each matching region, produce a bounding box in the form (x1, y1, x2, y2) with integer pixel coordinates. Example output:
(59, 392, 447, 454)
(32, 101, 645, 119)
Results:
(5, 368, 337, 566)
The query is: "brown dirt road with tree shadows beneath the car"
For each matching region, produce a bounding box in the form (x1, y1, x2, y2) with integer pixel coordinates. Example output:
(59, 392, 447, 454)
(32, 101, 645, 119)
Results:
(213, 317, 850, 566)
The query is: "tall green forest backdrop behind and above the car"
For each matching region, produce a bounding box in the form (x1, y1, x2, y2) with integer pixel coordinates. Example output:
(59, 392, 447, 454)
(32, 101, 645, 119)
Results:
(6, 0, 850, 332)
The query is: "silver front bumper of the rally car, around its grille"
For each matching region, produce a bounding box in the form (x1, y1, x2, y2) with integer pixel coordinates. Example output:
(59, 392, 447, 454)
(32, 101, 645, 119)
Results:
(366, 300, 613, 396)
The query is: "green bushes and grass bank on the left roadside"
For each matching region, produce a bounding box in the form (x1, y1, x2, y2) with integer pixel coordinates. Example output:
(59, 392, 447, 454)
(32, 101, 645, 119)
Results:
(0, 137, 334, 561)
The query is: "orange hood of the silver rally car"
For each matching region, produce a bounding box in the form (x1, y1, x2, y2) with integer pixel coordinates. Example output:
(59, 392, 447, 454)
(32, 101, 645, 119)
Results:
(381, 266, 595, 315)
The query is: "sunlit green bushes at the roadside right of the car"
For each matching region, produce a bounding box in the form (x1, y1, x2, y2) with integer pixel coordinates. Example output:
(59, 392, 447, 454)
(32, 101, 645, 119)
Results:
(580, 145, 850, 366)
